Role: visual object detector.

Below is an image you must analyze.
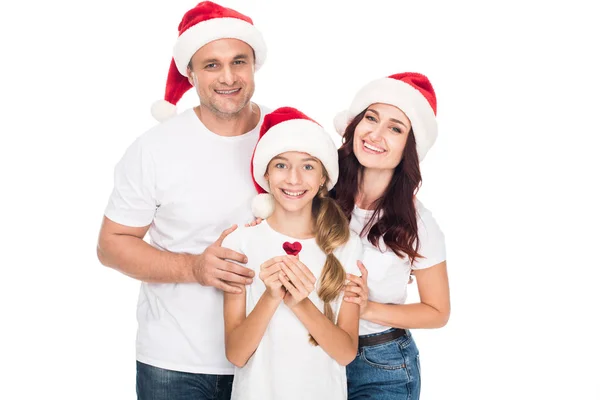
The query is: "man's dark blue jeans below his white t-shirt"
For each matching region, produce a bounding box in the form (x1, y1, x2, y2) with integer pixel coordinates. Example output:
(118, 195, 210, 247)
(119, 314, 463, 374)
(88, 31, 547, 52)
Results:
(136, 361, 233, 400)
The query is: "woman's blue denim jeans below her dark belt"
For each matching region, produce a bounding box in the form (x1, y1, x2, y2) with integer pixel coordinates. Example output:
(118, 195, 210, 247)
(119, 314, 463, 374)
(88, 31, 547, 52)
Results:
(346, 329, 421, 400)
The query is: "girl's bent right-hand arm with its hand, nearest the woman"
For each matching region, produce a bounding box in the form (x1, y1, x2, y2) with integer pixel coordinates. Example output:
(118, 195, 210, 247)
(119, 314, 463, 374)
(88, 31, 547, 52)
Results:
(280, 258, 360, 365)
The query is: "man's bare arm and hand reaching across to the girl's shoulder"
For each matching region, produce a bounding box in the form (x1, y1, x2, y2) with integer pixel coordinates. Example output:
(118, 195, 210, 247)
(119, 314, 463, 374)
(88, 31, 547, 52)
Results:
(97, 217, 254, 293)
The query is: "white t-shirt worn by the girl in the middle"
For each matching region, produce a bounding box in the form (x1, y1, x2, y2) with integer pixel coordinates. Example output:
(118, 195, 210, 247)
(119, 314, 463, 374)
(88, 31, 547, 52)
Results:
(223, 221, 362, 400)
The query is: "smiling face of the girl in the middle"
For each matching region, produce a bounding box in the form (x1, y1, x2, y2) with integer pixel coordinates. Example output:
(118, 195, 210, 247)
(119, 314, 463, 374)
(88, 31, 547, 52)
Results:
(265, 151, 325, 216)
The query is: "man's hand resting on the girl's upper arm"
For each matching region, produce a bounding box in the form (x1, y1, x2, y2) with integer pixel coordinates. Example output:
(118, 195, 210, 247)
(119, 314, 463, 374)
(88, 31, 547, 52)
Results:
(192, 225, 254, 293)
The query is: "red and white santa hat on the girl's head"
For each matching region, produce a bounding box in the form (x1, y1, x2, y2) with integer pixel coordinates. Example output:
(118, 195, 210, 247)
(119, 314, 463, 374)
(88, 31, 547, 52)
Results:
(250, 107, 339, 219)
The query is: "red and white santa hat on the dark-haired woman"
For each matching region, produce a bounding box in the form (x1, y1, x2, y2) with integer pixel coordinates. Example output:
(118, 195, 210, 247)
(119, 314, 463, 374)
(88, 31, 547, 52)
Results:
(334, 72, 437, 161)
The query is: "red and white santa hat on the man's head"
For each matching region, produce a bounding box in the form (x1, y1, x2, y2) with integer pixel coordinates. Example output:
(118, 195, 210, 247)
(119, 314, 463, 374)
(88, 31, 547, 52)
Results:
(151, 1, 267, 121)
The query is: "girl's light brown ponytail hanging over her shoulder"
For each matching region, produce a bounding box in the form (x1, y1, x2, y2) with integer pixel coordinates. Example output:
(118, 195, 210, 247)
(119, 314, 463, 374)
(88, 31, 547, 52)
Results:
(309, 167, 350, 346)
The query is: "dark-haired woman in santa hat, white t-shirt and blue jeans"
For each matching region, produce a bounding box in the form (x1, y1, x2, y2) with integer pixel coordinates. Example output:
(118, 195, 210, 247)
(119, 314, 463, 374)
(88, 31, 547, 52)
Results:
(335, 73, 450, 400)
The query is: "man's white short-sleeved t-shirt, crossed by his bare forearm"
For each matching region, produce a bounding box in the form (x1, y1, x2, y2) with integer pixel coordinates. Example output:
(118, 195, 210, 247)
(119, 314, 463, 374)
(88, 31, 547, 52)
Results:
(105, 107, 268, 374)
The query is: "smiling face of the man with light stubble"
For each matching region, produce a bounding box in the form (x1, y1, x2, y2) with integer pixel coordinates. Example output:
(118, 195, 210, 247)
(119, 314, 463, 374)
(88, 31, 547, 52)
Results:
(188, 39, 254, 118)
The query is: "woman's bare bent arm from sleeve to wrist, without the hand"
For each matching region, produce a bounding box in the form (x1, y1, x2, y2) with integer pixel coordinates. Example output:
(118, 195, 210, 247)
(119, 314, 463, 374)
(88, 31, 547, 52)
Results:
(360, 261, 450, 329)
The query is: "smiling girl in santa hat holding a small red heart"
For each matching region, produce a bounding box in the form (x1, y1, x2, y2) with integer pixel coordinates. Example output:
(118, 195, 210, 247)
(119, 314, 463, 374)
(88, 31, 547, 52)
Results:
(223, 108, 362, 400)
